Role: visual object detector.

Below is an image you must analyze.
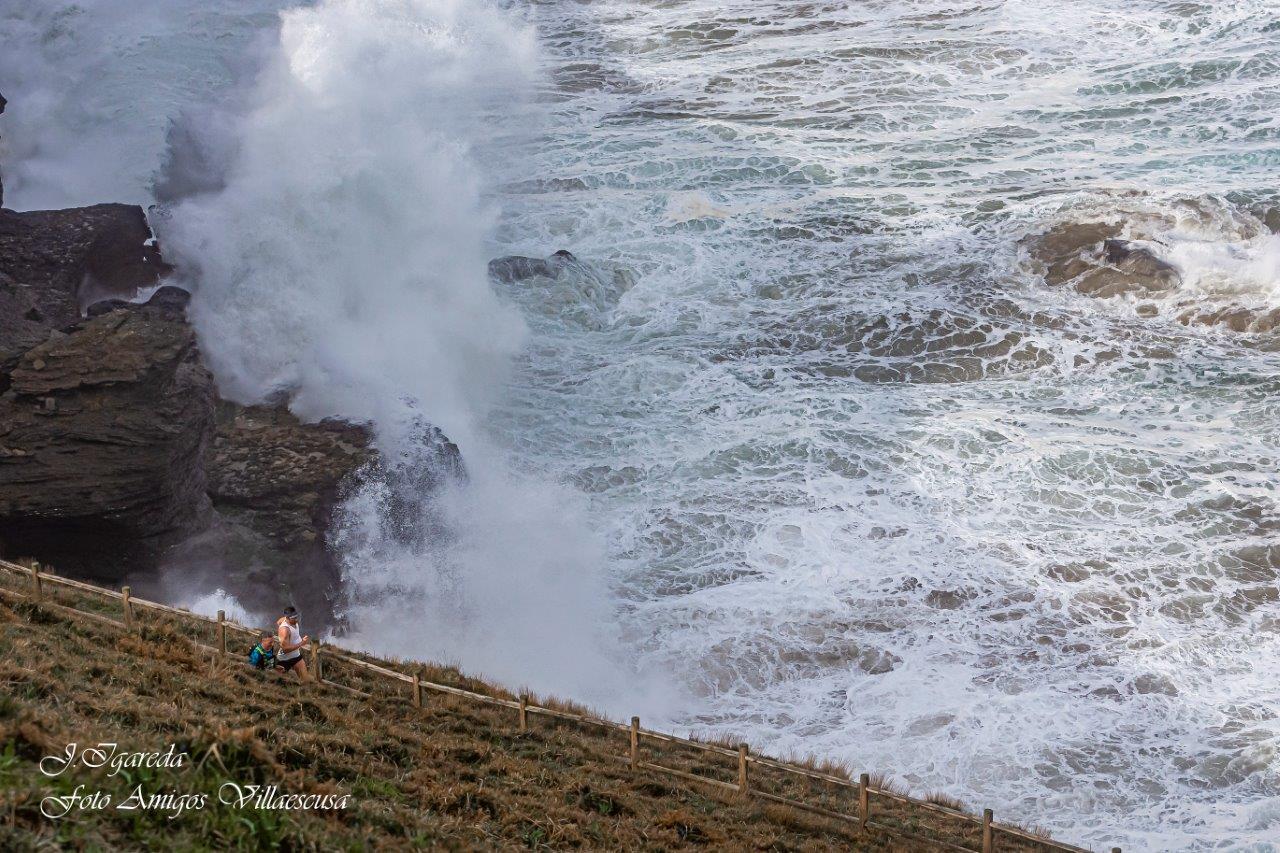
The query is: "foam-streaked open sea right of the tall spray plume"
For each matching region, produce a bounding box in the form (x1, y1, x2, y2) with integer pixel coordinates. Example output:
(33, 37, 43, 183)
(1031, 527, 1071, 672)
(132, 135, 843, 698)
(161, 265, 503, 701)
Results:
(483, 0, 1280, 850)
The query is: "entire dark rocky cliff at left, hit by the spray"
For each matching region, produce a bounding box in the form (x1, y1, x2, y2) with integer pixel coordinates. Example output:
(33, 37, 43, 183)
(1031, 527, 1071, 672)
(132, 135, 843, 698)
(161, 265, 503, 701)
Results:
(0, 154, 465, 604)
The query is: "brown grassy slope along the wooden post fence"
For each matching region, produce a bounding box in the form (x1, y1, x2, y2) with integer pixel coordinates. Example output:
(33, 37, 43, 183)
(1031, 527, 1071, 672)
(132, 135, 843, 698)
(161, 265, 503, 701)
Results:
(0, 579, 1064, 850)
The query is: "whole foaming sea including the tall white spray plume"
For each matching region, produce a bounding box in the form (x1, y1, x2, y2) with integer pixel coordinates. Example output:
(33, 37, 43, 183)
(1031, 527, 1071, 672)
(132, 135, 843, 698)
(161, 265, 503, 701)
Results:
(0, 0, 1280, 850)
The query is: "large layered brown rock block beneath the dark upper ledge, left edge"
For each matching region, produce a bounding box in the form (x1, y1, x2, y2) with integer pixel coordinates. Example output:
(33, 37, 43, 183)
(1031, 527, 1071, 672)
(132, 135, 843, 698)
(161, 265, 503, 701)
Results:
(0, 288, 214, 578)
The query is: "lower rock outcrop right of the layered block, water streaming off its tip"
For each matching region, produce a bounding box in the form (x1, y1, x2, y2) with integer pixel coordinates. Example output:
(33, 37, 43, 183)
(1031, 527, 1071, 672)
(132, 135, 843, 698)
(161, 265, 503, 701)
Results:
(169, 401, 465, 625)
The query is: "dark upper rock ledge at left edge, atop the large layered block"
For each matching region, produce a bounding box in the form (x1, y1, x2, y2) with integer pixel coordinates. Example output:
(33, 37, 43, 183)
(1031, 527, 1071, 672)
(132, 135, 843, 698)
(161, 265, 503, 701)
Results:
(0, 205, 168, 361)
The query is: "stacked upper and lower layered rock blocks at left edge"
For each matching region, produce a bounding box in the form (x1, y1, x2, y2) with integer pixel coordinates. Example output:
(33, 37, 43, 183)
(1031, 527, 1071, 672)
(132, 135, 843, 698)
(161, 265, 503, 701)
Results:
(0, 195, 202, 575)
